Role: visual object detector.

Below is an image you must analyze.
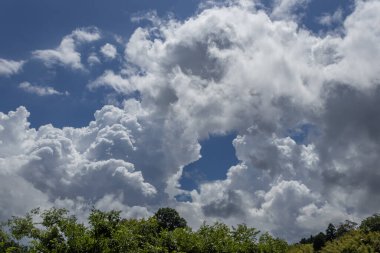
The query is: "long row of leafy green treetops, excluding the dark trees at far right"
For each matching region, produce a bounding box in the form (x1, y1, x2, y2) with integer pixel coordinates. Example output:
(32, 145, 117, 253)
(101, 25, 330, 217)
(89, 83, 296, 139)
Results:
(0, 208, 288, 252)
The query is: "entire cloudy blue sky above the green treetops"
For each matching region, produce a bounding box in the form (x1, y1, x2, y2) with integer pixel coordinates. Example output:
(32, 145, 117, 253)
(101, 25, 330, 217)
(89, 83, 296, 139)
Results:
(0, 0, 380, 241)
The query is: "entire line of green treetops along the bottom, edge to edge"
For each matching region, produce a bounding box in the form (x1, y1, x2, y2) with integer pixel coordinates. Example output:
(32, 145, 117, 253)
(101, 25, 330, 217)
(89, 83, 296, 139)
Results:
(0, 208, 380, 253)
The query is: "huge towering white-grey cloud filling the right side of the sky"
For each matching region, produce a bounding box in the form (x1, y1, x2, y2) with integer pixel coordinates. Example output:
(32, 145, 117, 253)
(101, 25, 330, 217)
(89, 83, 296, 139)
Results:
(120, 1, 380, 239)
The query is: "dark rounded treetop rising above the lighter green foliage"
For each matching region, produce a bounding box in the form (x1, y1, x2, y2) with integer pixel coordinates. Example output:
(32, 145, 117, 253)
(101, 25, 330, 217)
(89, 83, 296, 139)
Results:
(154, 207, 187, 231)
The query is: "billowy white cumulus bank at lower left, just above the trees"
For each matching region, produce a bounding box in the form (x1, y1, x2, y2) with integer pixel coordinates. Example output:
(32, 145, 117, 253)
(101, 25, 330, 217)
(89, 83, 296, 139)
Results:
(0, 107, 157, 218)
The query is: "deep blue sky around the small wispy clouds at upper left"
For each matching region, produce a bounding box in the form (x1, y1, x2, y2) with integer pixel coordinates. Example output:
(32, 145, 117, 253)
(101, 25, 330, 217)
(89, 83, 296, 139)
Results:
(0, 0, 199, 127)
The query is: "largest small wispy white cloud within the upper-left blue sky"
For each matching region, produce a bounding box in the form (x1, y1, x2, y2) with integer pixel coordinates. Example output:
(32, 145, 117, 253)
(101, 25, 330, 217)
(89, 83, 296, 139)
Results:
(33, 28, 101, 70)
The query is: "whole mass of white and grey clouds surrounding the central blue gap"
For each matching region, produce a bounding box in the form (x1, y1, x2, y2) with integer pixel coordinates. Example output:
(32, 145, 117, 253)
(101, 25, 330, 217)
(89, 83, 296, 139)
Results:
(0, 0, 380, 240)
